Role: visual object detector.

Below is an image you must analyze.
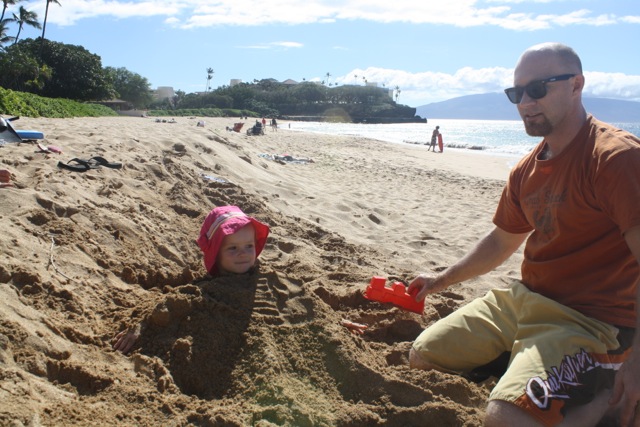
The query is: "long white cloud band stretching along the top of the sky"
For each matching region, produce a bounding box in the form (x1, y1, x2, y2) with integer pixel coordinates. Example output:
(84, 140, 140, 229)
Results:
(20, 0, 640, 31)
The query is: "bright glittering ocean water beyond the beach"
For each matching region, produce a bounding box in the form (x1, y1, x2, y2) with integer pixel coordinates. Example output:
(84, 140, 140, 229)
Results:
(290, 119, 640, 157)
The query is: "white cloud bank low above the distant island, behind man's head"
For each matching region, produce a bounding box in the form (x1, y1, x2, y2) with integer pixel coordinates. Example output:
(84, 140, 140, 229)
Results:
(332, 67, 640, 105)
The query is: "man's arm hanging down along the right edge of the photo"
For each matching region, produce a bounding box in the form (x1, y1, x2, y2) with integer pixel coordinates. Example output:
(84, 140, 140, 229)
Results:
(609, 226, 640, 426)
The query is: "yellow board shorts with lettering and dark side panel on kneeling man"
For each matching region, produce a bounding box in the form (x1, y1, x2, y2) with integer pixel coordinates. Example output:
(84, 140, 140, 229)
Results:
(413, 282, 634, 426)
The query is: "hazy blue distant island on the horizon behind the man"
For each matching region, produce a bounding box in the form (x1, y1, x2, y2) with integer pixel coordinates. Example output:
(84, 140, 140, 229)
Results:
(416, 93, 640, 123)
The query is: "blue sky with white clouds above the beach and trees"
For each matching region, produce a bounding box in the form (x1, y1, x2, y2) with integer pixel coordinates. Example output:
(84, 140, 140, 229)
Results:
(7, 0, 640, 107)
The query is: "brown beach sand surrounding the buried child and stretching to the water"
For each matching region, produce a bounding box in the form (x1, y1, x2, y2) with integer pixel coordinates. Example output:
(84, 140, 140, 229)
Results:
(0, 117, 520, 427)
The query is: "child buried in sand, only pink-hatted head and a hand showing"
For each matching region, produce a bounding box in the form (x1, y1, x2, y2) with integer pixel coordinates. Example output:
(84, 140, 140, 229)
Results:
(113, 206, 269, 353)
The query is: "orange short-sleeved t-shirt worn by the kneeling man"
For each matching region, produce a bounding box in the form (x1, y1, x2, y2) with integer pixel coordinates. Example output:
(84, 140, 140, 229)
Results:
(493, 116, 640, 327)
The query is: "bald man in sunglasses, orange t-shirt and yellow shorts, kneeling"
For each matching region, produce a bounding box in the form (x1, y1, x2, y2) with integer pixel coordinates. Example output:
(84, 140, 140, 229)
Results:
(409, 43, 640, 427)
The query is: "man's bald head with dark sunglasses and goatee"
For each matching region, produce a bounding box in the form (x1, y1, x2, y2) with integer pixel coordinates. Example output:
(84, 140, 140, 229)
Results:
(505, 43, 584, 136)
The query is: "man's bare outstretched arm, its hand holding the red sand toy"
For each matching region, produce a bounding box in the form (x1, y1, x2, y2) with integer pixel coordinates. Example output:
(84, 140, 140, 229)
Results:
(408, 227, 529, 301)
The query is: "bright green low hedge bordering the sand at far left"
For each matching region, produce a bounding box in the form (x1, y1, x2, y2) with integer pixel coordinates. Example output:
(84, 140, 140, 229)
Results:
(0, 87, 117, 118)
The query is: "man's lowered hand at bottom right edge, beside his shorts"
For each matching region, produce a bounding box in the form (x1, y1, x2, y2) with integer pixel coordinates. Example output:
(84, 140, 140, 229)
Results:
(609, 348, 640, 427)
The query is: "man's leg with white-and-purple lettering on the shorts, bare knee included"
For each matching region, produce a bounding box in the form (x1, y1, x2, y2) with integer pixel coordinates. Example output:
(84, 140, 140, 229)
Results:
(486, 284, 633, 427)
